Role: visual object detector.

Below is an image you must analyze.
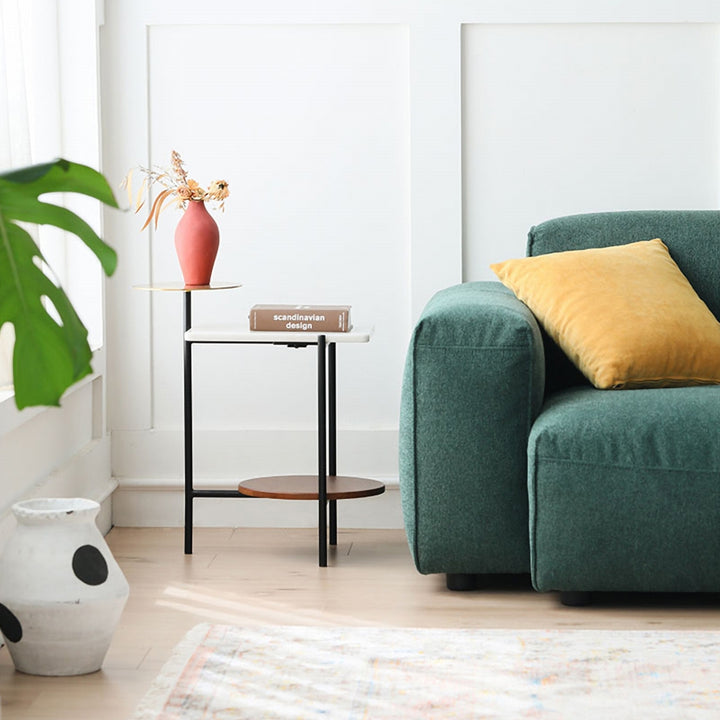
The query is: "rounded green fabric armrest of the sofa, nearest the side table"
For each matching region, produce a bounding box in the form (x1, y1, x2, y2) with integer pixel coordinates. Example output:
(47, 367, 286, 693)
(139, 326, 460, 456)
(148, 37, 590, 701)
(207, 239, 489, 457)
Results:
(400, 282, 545, 574)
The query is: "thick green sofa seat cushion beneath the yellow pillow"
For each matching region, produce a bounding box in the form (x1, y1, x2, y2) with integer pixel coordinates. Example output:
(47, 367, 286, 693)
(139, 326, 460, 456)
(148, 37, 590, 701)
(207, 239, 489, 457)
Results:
(528, 386, 720, 592)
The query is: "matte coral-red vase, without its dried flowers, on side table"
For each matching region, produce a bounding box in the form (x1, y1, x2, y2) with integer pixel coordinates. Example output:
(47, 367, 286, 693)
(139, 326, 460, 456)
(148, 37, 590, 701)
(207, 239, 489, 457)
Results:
(175, 200, 220, 285)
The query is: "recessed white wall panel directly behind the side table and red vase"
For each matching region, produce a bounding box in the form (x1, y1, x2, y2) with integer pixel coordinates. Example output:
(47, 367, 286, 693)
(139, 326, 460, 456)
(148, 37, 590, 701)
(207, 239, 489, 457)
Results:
(148, 25, 409, 436)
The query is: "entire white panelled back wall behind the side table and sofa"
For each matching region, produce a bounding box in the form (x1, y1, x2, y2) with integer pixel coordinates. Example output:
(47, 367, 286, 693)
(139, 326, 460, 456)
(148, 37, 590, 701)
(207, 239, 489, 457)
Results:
(103, 0, 720, 525)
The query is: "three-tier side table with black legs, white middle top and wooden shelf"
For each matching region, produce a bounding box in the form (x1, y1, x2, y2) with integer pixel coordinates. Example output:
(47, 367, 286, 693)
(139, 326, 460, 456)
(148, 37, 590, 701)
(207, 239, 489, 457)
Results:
(137, 282, 385, 567)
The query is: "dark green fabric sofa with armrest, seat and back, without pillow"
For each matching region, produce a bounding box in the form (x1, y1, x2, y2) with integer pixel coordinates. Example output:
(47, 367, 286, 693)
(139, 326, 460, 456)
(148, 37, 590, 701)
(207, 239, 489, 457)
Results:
(400, 211, 720, 604)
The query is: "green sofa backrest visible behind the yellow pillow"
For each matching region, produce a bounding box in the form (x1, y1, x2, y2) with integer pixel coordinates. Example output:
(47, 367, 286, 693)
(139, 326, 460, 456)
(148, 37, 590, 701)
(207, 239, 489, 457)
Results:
(527, 210, 720, 392)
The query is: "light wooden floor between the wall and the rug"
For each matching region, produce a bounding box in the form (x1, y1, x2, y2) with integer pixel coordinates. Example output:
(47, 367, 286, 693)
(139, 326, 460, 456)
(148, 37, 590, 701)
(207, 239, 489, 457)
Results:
(0, 528, 720, 720)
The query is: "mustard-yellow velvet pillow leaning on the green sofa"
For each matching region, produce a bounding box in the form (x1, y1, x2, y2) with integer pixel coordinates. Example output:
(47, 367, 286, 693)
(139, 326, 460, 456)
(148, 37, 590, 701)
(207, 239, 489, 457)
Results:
(490, 239, 720, 389)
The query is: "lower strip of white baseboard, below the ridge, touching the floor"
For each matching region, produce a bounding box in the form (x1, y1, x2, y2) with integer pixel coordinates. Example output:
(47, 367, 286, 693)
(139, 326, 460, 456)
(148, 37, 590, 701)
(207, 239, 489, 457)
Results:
(113, 478, 403, 528)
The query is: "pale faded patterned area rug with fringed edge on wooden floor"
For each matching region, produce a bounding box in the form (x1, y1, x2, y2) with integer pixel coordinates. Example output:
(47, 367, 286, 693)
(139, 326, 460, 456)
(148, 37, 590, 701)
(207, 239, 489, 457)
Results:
(133, 624, 720, 720)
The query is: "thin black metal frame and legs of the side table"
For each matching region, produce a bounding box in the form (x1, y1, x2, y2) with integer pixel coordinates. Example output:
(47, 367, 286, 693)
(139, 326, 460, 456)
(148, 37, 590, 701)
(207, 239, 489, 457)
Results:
(183, 290, 344, 567)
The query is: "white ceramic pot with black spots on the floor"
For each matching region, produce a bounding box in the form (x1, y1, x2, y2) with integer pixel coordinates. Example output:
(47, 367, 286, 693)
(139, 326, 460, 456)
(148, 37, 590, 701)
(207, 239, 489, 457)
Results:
(0, 498, 129, 675)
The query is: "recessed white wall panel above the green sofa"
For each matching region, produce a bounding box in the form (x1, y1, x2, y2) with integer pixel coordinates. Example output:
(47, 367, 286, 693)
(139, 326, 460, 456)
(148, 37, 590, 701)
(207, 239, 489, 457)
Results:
(463, 23, 720, 280)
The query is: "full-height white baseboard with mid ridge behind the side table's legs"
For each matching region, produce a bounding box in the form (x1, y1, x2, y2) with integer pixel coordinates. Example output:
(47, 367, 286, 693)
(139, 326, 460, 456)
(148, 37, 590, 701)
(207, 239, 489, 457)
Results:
(112, 428, 403, 528)
